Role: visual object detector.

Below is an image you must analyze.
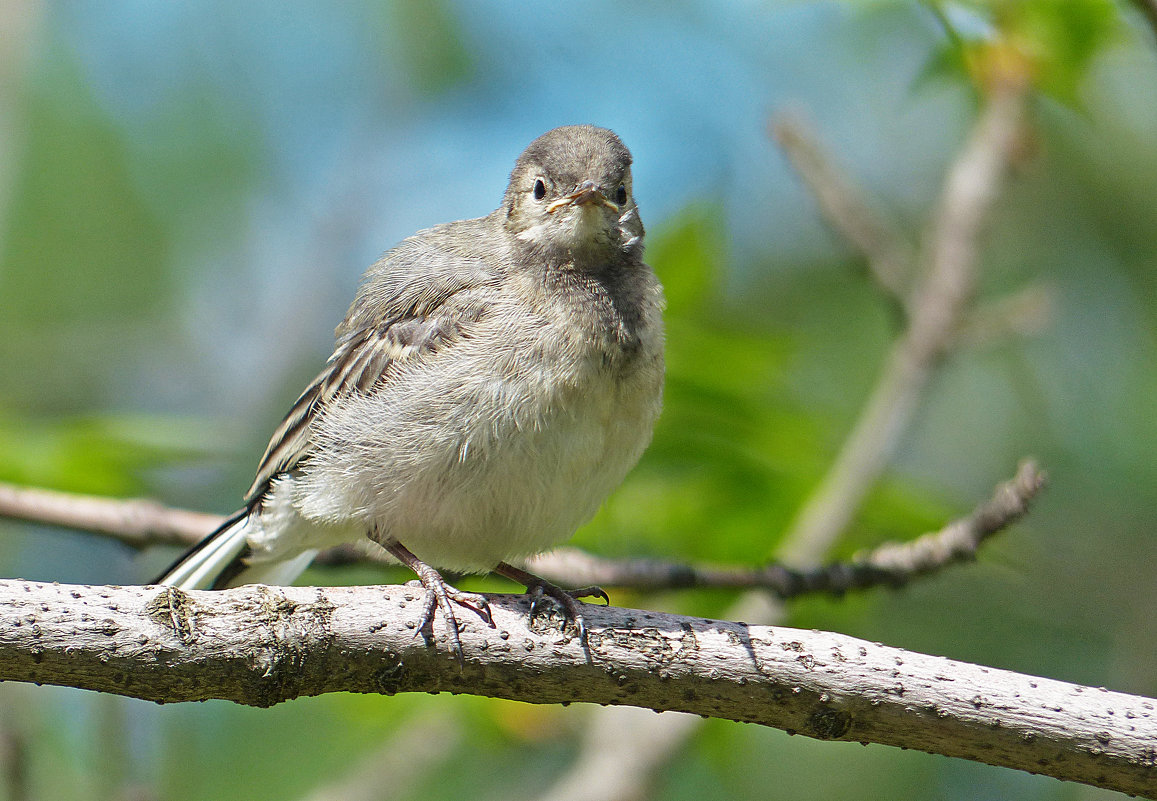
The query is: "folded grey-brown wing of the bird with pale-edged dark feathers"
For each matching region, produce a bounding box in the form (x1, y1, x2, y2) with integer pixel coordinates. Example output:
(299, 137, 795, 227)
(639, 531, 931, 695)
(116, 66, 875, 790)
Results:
(245, 221, 498, 506)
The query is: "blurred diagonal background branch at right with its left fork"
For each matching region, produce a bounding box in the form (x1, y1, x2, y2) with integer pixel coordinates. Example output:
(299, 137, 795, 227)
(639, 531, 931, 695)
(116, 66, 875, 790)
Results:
(541, 74, 1029, 801)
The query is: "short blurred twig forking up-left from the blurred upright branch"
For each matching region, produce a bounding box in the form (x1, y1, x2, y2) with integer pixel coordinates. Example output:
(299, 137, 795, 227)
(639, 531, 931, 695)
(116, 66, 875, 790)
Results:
(771, 113, 914, 310)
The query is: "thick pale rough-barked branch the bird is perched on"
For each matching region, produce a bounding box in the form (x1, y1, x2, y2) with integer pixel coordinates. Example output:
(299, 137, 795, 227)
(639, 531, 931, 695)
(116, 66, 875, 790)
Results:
(0, 580, 1157, 798)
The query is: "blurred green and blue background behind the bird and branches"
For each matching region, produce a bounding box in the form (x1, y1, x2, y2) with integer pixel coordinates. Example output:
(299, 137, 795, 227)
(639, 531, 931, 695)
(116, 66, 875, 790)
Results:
(0, 0, 1157, 801)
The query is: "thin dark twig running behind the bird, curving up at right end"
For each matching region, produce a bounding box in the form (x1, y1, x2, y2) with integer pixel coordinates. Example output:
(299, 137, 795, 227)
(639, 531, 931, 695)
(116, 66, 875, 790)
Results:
(0, 461, 1044, 598)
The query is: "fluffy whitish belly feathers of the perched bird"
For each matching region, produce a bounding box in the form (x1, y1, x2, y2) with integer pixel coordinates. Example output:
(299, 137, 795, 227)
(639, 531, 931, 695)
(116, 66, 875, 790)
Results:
(250, 295, 663, 572)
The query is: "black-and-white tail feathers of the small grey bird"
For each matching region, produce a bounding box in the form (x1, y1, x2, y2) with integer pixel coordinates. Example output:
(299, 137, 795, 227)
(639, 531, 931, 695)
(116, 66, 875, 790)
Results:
(152, 509, 317, 589)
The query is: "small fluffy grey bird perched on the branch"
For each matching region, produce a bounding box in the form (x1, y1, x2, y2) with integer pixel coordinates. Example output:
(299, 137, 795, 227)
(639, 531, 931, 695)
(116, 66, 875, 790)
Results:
(154, 125, 664, 662)
